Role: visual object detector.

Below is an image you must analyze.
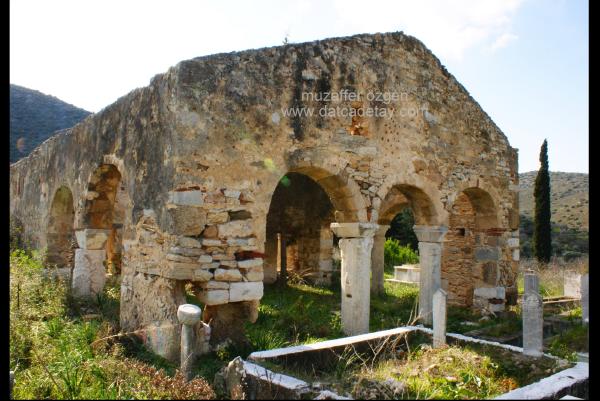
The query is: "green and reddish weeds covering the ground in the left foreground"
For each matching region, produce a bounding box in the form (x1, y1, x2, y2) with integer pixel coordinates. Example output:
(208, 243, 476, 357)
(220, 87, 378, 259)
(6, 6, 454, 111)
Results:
(10, 250, 215, 399)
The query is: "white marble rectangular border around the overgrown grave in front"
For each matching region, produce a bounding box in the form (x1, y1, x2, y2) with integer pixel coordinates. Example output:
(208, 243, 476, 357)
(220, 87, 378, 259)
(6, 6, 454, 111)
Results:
(232, 325, 589, 399)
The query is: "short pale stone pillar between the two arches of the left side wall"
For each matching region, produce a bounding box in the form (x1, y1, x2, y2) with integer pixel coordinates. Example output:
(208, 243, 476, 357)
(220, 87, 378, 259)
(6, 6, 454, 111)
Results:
(72, 228, 110, 297)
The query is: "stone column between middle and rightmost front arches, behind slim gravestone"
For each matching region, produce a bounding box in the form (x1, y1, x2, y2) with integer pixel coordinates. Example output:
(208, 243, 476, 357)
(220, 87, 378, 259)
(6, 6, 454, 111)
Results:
(413, 225, 448, 324)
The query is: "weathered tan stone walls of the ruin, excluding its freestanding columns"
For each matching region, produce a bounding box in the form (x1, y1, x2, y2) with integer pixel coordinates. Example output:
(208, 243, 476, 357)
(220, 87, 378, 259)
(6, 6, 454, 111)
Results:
(10, 33, 518, 355)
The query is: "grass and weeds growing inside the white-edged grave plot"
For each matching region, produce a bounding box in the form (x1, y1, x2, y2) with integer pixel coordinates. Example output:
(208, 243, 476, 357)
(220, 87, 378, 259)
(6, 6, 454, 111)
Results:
(264, 333, 565, 399)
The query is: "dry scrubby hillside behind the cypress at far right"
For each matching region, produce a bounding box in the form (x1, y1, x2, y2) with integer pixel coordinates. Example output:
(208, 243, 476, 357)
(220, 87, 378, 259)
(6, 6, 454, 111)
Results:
(519, 171, 589, 231)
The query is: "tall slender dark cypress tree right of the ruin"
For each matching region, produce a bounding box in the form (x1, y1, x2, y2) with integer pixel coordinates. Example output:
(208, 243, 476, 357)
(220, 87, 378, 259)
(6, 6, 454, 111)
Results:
(533, 139, 552, 263)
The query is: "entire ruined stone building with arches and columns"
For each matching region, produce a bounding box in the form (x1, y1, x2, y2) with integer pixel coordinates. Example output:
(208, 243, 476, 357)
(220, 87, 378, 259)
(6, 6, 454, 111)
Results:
(10, 33, 519, 359)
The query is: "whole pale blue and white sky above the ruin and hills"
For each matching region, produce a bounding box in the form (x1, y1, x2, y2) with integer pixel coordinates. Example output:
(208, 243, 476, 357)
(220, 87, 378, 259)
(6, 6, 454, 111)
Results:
(10, 0, 589, 172)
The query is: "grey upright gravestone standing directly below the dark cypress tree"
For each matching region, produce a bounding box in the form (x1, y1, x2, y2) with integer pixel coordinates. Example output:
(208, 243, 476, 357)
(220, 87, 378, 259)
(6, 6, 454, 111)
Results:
(522, 273, 544, 357)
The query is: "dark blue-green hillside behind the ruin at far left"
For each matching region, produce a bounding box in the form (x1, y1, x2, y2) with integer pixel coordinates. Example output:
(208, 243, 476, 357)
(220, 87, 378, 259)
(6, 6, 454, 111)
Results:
(10, 84, 90, 163)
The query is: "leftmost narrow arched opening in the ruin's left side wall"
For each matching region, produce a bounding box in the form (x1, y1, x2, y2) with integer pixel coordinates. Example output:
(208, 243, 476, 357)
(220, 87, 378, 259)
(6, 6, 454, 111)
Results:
(46, 186, 75, 268)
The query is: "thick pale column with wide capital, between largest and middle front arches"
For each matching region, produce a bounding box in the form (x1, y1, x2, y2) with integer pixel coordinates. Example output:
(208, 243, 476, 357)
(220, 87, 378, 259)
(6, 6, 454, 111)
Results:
(331, 223, 379, 335)
